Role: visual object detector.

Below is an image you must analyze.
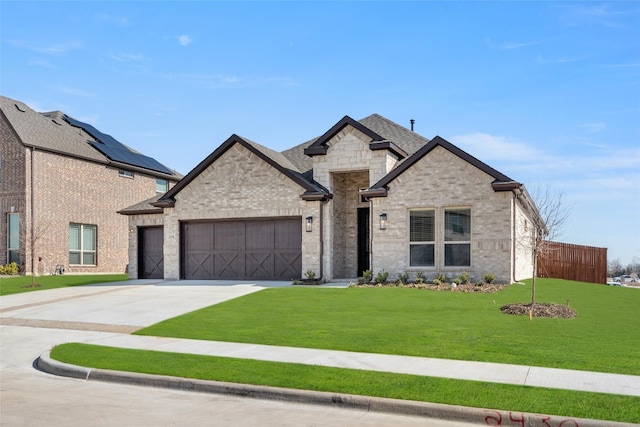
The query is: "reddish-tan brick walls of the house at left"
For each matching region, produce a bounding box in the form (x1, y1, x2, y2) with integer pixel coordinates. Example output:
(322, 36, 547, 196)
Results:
(0, 107, 175, 274)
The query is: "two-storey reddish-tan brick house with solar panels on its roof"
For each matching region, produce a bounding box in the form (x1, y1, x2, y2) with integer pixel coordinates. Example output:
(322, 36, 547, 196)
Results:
(0, 97, 182, 274)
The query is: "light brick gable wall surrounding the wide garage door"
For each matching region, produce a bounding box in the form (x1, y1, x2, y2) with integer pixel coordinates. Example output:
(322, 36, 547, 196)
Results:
(164, 144, 322, 279)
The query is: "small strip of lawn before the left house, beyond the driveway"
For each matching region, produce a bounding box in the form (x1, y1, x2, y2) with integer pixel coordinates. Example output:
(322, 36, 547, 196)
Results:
(0, 274, 129, 296)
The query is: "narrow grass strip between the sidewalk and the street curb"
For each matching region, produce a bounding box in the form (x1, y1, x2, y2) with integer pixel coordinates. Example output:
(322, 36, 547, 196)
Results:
(51, 343, 640, 423)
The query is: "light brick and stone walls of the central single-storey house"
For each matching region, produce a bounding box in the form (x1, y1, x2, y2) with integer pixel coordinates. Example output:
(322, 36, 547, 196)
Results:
(129, 119, 531, 282)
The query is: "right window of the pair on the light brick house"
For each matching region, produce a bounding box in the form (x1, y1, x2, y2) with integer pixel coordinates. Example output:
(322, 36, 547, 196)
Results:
(444, 209, 471, 267)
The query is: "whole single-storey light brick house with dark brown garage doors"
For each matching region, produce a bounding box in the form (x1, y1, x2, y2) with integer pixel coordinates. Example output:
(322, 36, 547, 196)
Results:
(120, 114, 537, 282)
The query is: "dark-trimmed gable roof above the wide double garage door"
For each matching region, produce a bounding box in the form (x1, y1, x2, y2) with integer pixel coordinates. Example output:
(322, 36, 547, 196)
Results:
(152, 134, 331, 207)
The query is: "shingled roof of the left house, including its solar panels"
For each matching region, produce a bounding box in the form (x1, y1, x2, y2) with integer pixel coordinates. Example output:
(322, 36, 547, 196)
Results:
(0, 96, 181, 180)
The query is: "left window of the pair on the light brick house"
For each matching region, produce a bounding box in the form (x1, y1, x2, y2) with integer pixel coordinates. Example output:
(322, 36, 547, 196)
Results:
(409, 210, 436, 267)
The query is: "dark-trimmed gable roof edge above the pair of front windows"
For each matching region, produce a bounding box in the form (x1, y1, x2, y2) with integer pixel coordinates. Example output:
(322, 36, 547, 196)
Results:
(361, 136, 522, 197)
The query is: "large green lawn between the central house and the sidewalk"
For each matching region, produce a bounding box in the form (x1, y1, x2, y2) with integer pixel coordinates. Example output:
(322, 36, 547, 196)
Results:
(136, 279, 640, 375)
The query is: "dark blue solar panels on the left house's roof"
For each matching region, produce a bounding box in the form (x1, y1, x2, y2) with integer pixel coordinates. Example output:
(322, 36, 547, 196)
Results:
(65, 116, 173, 175)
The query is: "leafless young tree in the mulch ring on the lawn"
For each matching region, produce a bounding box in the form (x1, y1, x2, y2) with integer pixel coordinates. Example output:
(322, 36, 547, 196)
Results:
(518, 186, 570, 314)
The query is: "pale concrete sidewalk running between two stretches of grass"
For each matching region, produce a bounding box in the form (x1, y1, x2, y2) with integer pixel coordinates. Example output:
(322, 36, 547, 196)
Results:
(46, 334, 640, 396)
